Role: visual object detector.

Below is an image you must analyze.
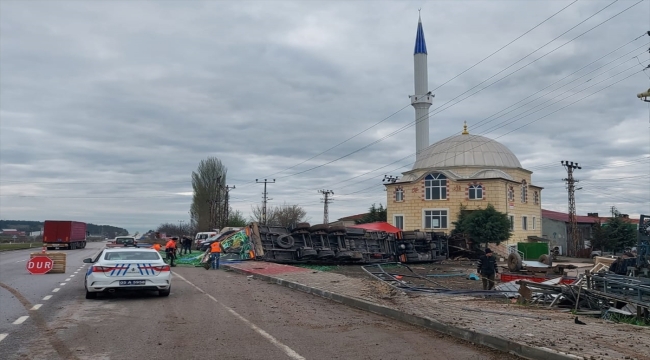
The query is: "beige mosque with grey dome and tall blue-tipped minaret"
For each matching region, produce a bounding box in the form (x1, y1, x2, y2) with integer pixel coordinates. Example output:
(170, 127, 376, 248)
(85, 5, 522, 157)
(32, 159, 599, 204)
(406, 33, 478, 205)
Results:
(386, 18, 542, 255)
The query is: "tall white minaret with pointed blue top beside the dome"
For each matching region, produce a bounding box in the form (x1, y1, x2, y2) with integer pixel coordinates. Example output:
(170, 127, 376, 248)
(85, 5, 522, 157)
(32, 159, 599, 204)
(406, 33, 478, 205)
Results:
(411, 16, 434, 160)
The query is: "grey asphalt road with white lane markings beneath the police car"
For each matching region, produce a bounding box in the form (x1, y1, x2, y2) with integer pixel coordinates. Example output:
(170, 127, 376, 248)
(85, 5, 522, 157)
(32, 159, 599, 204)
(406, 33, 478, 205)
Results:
(0, 244, 515, 360)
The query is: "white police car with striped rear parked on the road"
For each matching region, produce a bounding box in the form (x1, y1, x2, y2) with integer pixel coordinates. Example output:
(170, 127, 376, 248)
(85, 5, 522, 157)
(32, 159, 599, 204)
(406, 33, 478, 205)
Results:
(83, 248, 171, 299)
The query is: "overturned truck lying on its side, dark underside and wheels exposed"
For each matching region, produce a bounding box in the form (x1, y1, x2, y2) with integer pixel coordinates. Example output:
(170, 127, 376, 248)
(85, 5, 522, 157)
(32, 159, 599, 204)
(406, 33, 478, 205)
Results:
(246, 223, 448, 264)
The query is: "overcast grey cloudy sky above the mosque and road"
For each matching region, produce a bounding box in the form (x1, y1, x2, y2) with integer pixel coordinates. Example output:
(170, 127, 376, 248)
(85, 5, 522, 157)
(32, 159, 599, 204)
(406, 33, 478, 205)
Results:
(0, 0, 650, 231)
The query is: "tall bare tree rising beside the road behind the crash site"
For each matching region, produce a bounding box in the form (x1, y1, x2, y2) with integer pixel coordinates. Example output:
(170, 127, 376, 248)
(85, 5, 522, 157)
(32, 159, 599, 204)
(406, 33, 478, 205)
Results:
(190, 157, 228, 231)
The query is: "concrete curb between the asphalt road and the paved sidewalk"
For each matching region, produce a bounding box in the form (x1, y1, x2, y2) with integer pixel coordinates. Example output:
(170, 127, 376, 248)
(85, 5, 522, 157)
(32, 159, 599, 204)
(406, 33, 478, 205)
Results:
(221, 264, 583, 360)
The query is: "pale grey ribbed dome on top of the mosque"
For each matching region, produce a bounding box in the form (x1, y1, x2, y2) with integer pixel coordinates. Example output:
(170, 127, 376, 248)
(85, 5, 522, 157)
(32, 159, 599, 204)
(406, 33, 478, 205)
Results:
(413, 126, 521, 170)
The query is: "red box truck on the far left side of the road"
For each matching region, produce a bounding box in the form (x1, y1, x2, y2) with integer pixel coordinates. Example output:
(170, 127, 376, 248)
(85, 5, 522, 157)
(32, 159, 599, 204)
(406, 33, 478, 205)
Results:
(43, 220, 87, 250)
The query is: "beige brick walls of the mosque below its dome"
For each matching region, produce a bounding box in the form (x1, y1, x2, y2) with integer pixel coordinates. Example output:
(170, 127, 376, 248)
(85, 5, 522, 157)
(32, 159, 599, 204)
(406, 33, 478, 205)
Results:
(386, 168, 542, 249)
